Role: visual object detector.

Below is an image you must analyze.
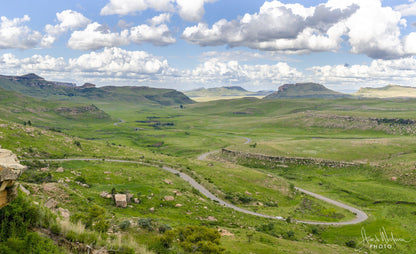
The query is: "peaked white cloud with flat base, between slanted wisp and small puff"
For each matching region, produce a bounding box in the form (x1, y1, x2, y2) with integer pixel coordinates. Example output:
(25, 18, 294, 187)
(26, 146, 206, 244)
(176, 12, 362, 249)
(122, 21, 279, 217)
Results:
(68, 22, 130, 50)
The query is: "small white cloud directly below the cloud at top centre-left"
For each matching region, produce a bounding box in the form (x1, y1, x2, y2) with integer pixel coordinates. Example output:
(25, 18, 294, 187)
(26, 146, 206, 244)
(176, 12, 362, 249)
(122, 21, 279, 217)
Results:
(129, 24, 176, 46)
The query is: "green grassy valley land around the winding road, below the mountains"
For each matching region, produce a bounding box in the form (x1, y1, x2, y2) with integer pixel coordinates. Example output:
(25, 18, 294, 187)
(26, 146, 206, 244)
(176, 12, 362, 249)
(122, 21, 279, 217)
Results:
(0, 73, 416, 253)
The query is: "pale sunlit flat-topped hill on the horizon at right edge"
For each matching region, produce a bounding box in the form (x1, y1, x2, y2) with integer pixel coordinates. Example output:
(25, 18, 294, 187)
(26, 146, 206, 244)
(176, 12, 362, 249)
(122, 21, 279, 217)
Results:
(353, 85, 416, 98)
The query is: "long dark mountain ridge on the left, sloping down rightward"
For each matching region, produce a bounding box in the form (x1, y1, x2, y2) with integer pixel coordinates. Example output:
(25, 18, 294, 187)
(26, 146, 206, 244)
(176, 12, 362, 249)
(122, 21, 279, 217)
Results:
(0, 74, 193, 106)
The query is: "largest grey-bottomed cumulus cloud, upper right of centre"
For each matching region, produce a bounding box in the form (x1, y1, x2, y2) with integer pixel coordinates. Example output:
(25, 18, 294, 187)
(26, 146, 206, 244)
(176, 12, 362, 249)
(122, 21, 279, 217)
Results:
(182, 1, 358, 53)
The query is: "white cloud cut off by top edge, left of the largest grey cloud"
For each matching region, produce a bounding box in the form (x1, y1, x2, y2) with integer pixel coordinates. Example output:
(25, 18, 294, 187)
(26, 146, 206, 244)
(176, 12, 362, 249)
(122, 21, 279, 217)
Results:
(101, 0, 216, 22)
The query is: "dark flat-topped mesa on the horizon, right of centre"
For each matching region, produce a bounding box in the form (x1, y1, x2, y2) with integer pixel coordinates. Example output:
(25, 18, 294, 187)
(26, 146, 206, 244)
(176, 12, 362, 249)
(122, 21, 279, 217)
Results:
(264, 83, 351, 99)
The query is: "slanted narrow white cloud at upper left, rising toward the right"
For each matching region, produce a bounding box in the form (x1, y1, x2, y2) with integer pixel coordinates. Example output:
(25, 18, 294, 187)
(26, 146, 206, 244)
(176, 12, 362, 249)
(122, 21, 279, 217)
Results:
(41, 10, 91, 47)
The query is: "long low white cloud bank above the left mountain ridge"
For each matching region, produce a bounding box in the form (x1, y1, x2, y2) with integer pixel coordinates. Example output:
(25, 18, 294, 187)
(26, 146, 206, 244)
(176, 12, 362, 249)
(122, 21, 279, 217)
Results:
(0, 48, 173, 80)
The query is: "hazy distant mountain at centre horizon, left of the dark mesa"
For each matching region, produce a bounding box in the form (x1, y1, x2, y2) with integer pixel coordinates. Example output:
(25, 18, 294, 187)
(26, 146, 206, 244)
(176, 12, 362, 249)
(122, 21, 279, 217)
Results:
(184, 86, 273, 98)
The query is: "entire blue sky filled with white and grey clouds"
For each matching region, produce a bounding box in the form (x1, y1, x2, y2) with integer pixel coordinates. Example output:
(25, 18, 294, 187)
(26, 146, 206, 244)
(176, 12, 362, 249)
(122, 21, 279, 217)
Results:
(0, 0, 416, 92)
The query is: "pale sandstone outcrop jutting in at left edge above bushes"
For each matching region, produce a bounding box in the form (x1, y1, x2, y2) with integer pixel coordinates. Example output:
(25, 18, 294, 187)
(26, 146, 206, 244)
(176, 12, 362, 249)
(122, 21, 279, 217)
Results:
(0, 149, 26, 208)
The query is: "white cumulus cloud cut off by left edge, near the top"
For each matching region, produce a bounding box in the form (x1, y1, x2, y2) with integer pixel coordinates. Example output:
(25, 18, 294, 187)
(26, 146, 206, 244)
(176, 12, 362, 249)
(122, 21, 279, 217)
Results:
(0, 15, 42, 49)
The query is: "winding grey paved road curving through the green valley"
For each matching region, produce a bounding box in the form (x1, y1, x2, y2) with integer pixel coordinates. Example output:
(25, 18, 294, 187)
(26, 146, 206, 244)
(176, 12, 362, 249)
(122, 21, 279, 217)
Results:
(30, 158, 368, 226)
